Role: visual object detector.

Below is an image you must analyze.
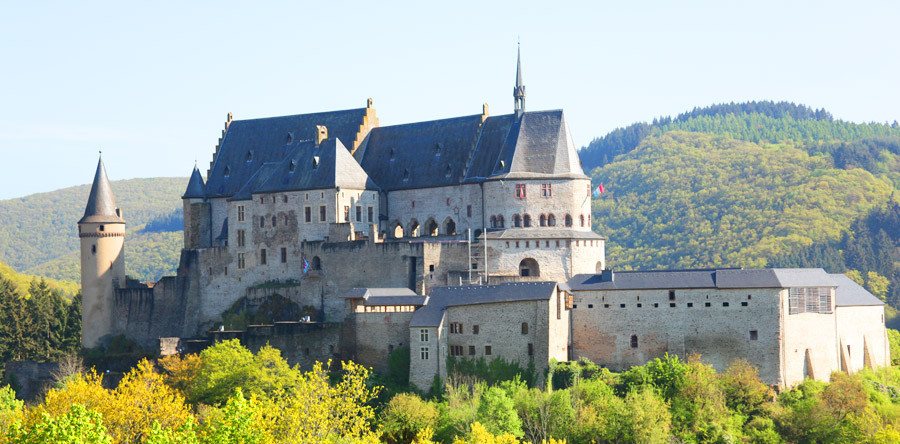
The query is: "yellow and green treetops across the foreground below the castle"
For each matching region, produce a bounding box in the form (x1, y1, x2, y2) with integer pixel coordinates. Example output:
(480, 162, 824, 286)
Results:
(0, 341, 900, 444)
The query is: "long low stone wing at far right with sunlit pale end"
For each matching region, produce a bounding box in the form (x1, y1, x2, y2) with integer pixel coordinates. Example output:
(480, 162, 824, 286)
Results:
(568, 268, 890, 387)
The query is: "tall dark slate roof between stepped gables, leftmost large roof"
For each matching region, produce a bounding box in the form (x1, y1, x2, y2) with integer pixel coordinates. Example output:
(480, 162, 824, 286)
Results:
(206, 108, 366, 197)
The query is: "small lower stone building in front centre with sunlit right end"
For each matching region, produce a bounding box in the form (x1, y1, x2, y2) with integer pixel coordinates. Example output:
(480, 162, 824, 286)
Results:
(409, 282, 570, 390)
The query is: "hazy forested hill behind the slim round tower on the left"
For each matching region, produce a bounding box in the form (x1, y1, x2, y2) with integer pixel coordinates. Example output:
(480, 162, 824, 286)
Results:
(0, 178, 188, 282)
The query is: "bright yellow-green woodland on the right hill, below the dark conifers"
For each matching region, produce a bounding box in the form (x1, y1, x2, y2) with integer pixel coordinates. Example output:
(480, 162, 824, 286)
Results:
(593, 132, 892, 269)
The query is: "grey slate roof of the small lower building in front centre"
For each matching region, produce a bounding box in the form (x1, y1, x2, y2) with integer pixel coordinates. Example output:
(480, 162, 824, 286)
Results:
(409, 282, 556, 327)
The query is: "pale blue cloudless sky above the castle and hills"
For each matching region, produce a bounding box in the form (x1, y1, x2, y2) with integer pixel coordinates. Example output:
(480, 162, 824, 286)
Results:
(0, 1, 900, 199)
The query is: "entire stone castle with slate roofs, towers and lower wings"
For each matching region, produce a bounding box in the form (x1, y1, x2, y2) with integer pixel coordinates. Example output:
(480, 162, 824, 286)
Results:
(78, 48, 889, 387)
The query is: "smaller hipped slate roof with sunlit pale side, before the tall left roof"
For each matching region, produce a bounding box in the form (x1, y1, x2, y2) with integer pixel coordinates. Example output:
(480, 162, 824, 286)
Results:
(253, 138, 377, 193)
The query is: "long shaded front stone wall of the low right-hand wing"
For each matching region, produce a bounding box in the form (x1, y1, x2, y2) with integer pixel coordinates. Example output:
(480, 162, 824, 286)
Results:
(572, 289, 790, 384)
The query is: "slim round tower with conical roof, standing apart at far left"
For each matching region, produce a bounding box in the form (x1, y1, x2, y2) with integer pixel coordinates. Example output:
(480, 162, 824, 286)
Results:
(78, 158, 125, 348)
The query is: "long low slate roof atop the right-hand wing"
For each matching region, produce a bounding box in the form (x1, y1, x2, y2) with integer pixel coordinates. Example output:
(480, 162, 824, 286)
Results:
(568, 268, 837, 291)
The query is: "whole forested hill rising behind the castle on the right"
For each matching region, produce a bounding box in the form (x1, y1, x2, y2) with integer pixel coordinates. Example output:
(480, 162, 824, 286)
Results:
(580, 102, 900, 306)
